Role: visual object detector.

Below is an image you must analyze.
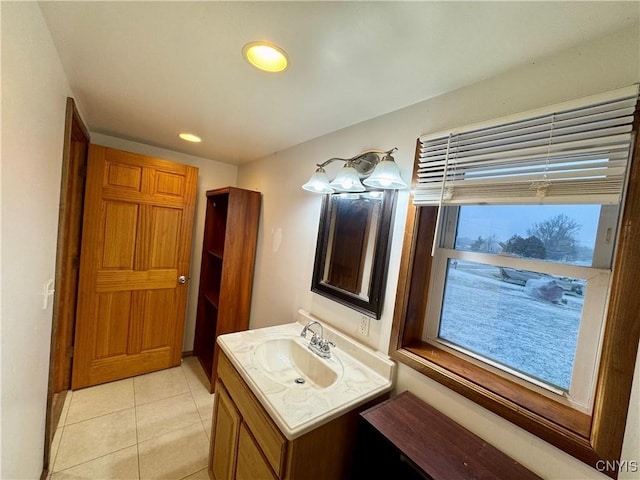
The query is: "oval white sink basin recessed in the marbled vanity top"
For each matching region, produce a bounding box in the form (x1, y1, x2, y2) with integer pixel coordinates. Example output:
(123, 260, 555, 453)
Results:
(253, 336, 343, 389)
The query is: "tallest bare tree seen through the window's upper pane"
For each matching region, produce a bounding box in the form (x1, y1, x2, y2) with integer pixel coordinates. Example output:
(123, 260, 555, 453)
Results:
(527, 213, 582, 260)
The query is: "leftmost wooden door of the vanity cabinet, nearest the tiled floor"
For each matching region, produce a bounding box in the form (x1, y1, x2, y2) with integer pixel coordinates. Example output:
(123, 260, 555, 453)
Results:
(209, 382, 242, 480)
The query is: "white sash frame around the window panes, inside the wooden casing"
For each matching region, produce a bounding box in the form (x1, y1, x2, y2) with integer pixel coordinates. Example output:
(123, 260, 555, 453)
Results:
(423, 205, 620, 412)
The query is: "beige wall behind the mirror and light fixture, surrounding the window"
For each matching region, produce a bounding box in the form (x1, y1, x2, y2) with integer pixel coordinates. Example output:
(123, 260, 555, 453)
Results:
(238, 27, 640, 479)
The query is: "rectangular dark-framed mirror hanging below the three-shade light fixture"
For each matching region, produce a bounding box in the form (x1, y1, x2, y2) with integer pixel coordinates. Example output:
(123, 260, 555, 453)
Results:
(311, 190, 397, 319)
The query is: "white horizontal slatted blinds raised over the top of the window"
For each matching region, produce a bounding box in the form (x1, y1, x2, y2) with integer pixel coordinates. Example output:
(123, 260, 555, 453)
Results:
(414, 85, 638, 205)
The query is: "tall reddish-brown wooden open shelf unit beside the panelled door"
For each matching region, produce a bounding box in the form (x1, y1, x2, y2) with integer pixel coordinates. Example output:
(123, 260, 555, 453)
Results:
(193, 187, 262, 392)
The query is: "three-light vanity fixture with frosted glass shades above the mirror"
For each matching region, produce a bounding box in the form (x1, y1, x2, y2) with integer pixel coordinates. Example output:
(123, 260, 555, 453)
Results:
(302, 148, 407, 193)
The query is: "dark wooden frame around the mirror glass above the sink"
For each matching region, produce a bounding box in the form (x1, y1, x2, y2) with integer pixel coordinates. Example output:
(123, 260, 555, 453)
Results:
(311, 190, 397, 319)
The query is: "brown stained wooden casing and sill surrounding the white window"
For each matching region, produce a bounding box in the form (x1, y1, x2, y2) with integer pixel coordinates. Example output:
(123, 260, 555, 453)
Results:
(389, 103, 640, 478)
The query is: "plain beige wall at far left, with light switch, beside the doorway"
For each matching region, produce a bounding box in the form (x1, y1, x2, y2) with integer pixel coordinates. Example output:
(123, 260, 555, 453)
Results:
(0, 2, 70, 478)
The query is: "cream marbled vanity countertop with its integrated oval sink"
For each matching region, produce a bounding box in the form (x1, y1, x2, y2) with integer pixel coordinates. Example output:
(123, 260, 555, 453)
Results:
(217, 310, 395, 440)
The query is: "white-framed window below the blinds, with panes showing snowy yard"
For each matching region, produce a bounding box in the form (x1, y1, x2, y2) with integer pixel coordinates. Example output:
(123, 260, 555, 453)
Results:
(423, 205, 618, 412)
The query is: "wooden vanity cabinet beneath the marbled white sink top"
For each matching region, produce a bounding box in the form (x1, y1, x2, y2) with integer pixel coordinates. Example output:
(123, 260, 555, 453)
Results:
(209, 351, 378, 480)
